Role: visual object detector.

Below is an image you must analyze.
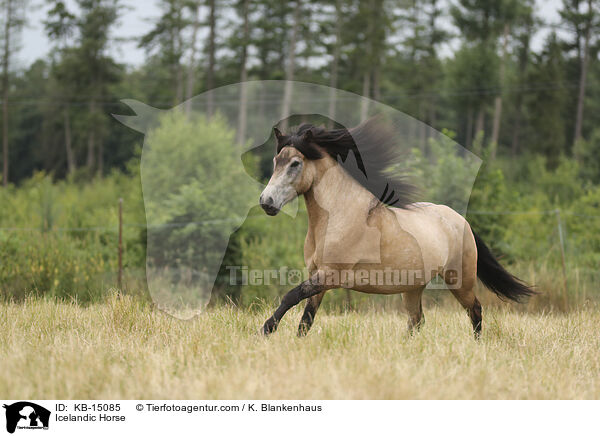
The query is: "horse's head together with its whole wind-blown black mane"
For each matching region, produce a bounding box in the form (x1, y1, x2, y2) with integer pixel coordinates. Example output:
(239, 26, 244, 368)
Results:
(260, 116, 422, 215)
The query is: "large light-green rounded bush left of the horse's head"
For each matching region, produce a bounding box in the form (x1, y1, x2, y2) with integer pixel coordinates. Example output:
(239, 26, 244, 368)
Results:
(141, 111, 259, 266)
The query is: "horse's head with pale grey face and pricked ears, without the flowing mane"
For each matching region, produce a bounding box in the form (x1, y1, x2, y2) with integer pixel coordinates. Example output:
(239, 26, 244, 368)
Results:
(260, 128, 322, 216)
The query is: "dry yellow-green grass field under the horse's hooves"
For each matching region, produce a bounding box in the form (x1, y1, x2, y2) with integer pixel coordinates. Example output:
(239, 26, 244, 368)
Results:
(0, 296, 600, 399)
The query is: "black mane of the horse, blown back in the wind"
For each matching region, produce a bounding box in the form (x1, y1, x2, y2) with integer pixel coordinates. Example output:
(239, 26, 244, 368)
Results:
(277, 117, 416, 207)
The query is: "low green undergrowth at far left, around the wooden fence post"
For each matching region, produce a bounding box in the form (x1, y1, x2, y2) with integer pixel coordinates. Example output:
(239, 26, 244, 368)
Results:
(0, 173, 145, 302)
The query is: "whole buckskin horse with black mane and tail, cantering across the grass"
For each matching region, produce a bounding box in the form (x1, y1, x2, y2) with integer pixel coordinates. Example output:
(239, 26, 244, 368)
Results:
(259, 117, 535, 338)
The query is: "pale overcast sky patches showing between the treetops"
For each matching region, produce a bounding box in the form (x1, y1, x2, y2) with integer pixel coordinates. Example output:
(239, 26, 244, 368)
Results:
(15, 0, 562, 68)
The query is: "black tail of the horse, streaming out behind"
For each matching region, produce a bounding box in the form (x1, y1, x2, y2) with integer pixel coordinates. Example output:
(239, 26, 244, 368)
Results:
(473, 232, 536, 302)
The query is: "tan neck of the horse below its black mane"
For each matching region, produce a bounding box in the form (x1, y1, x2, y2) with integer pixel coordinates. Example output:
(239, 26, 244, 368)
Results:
(304, 158, 376, 238)
